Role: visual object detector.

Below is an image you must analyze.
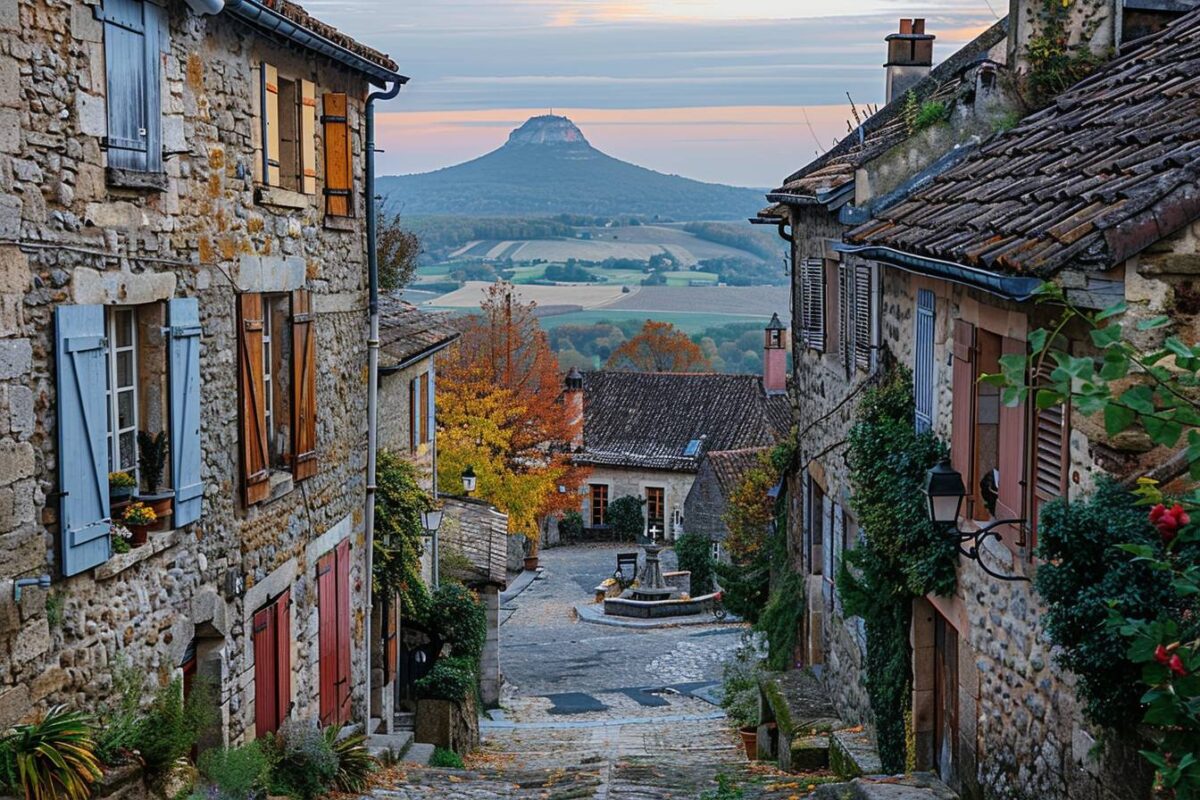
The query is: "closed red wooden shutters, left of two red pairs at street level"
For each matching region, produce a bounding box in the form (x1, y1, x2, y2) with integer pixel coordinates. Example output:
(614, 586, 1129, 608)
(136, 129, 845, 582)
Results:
(251, 591, 292, 736)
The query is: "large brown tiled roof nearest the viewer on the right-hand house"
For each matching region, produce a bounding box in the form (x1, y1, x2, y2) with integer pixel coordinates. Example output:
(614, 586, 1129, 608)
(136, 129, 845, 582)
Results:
(847, 12, 1200, 276)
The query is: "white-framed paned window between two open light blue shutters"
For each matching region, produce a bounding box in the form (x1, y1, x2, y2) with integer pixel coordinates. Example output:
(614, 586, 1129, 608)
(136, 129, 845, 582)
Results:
(106, 308, 138, 477)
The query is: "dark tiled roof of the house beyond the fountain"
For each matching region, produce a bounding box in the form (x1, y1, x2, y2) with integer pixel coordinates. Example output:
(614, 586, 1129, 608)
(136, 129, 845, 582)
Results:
(575, 372, 791, 471)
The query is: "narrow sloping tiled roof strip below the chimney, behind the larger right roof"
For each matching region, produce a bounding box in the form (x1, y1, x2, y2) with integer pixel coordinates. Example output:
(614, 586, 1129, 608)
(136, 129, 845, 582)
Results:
(760, 18, 1008, 208)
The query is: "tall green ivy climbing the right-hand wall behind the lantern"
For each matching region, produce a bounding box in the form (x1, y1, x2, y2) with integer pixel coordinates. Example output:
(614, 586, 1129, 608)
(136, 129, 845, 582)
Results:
(836, 367, 958, 772)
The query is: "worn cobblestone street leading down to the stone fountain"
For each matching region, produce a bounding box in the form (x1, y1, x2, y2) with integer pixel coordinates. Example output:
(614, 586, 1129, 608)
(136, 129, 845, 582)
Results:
(376, 546, 796, 800)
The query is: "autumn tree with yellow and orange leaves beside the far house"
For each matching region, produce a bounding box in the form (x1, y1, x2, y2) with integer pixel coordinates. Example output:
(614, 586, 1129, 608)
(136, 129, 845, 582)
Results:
(438, 281, 587, 548)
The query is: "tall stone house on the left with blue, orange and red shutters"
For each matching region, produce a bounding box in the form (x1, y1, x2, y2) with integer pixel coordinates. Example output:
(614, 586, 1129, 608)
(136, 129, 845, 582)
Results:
(0, 0, 404, 741)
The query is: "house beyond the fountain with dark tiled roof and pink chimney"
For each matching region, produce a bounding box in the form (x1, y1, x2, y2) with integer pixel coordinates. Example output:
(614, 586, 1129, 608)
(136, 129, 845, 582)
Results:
(564, 317, 791, 541)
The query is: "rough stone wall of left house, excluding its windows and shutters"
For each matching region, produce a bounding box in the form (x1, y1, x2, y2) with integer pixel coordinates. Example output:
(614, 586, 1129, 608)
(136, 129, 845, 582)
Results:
(0, 0, 398, 741)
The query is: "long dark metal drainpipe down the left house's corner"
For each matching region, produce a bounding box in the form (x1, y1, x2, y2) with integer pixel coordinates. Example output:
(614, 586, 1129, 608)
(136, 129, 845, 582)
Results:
(364, 82, 403, 734)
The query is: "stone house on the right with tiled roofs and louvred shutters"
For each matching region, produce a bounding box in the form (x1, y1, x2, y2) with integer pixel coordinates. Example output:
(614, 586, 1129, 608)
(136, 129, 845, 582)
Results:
(762, 0, 1200, 799)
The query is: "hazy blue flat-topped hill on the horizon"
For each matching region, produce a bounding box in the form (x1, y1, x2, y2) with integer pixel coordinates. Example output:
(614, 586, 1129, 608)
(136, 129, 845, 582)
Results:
(376, 115, 763, 221)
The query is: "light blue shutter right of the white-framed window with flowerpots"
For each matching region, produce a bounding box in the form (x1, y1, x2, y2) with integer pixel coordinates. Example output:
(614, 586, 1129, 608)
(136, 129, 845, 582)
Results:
(168, 297, 204, 528)
